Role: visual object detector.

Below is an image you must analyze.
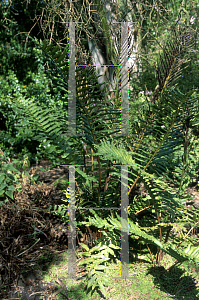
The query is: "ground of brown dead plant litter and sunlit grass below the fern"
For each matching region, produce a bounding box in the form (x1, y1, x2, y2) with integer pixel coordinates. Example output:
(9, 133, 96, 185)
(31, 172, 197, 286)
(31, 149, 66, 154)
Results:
(0, 160, 199, 300)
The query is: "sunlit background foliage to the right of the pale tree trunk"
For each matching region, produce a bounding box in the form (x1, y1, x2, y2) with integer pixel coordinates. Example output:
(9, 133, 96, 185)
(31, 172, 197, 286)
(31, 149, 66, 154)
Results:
(130, 1, 199, 133)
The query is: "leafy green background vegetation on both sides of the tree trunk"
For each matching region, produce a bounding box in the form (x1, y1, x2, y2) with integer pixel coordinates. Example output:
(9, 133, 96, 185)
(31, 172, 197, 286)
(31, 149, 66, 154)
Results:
(0, 1, 199, 163)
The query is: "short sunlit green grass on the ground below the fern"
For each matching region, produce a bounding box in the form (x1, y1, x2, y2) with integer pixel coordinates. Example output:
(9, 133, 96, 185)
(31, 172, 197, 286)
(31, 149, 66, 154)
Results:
(31, 246, 199, 300)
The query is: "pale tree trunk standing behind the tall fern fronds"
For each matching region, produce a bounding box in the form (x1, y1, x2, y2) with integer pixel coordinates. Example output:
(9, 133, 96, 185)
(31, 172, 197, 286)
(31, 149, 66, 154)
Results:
(84, 1, 141, 99)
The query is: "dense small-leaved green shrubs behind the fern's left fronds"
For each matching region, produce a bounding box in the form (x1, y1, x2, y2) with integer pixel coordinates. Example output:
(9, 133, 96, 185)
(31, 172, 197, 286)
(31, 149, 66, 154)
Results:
(0, 1, 67, 163)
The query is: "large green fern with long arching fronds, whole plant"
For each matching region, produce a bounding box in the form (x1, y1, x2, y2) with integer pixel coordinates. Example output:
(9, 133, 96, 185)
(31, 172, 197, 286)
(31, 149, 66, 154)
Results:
(5, 21, 198, 298)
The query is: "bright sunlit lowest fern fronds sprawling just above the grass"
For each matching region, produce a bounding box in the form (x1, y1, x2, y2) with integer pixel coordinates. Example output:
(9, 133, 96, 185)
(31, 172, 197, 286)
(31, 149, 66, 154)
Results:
(78, 210, 199, 297)
